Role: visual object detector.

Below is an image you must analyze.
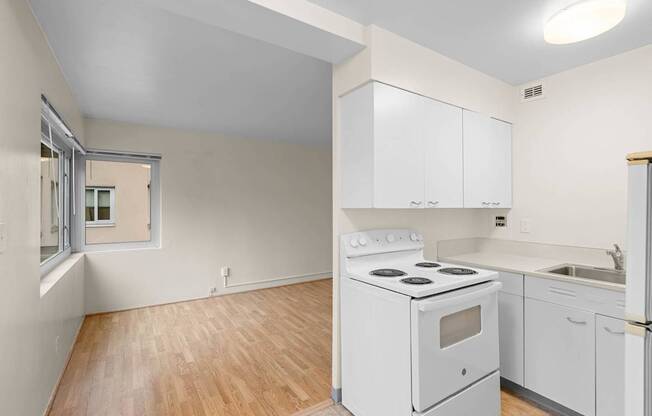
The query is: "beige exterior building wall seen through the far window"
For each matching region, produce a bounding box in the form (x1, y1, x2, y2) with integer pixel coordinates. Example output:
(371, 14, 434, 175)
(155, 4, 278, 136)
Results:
(86, 160, 150, 244)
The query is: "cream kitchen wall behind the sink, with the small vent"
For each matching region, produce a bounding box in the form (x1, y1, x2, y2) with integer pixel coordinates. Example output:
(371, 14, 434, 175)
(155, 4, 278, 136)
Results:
(487, 45, 652, 248)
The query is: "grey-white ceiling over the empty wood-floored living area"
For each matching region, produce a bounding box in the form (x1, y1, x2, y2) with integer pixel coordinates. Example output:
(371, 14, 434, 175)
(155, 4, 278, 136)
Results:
(30, 0, 331, 145)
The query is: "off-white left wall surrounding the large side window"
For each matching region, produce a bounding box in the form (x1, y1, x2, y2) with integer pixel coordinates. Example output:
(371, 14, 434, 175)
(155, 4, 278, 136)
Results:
(0, 0, 83, 416)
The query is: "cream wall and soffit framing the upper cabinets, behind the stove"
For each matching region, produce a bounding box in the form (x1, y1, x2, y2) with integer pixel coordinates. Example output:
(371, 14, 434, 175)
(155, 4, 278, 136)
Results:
(333, 26, 516, 394)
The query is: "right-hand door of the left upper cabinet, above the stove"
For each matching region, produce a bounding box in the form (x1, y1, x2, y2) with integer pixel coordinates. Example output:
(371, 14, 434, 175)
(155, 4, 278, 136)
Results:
(422, 97, 464, 208)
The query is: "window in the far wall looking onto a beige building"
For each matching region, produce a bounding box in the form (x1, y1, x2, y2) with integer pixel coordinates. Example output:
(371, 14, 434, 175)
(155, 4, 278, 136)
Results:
(82, 151, 160, 251)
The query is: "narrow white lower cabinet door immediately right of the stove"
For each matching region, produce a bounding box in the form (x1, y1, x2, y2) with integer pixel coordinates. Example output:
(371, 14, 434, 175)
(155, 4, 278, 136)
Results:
(498, 292, 524, 386)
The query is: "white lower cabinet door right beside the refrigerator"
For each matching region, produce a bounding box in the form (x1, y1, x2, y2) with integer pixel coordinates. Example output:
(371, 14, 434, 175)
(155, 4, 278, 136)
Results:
(595, 315, 625, 416)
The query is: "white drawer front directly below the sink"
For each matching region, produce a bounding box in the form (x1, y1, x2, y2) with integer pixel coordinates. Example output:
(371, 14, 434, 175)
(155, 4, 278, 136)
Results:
(525, 276, 625, 319)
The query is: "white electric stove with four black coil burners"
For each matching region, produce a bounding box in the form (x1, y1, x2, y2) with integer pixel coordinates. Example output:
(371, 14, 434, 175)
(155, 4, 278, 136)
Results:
(340, 229, 501, 416)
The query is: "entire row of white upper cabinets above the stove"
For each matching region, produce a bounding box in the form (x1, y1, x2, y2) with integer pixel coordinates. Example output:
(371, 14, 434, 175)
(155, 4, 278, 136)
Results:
(339, 82, 511, 209)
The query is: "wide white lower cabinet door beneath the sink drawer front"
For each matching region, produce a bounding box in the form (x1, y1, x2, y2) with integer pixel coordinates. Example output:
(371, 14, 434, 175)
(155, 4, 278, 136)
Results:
(525, 298, 595, 416)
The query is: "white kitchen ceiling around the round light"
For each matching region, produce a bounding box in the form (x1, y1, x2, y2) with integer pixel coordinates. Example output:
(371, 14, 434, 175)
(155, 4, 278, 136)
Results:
(309, 0, 652, 85)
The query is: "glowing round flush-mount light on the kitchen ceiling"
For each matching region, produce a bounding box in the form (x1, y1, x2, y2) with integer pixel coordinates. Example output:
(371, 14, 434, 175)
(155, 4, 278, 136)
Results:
(543, 0, 627, 45)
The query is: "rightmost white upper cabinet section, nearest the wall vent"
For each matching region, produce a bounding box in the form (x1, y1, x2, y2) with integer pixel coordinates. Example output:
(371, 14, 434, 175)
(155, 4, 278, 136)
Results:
(463, 110, 512, 208)
